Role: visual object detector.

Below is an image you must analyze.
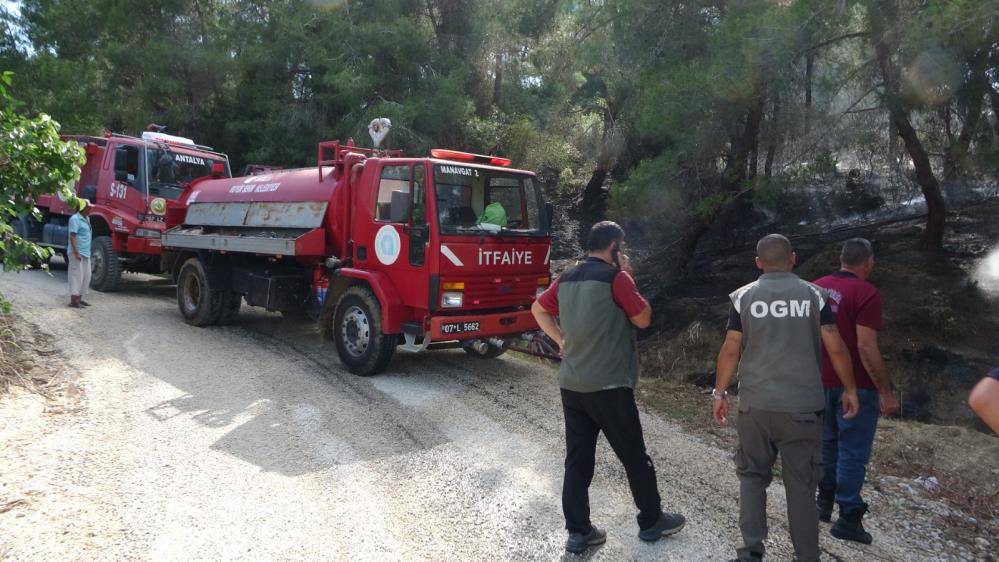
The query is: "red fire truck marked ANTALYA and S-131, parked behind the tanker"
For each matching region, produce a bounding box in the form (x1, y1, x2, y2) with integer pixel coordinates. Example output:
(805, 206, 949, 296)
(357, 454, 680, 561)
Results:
(15, 131, 230, 291)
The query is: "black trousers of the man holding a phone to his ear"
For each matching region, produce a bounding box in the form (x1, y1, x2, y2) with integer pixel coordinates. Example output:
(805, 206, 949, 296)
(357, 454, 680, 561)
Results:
(562, 387, 662, 534)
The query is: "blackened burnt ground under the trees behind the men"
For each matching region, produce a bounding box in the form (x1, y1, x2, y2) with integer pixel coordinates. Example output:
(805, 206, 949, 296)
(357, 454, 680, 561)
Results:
(641, 198, 999, 430)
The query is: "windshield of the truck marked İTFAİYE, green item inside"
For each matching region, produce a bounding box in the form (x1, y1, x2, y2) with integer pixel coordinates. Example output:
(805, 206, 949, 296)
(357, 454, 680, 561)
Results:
(434, 164, 548, 236)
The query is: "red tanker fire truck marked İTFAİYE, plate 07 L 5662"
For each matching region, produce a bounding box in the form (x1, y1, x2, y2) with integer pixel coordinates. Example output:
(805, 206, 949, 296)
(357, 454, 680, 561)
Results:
(163, 132, 552, 375)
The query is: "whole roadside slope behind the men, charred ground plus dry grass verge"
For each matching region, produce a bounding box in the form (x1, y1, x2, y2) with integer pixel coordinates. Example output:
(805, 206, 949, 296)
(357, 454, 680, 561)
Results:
(639, 198, 999, 548)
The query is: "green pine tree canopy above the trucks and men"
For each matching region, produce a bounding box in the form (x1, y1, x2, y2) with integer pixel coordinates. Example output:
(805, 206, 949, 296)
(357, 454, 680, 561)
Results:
(0, 0, 999, 280)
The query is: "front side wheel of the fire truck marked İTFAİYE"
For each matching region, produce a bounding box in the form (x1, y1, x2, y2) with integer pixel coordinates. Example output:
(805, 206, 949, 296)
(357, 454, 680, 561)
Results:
(332, 286, 399, 377)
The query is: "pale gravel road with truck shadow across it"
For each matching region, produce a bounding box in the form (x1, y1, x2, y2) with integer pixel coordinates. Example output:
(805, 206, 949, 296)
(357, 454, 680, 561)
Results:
(0, 264, 948, 561)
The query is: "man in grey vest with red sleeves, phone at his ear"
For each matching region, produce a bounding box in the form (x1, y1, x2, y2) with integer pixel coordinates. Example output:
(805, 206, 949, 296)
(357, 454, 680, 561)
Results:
(531, 221, 686, 553)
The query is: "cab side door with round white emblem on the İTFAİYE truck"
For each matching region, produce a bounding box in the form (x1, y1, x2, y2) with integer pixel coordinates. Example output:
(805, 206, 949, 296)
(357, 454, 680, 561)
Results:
(369, 164, 430, 311)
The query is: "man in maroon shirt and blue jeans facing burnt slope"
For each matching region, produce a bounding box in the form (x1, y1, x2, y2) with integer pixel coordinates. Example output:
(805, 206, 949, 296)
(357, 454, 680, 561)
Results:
(815, 238, 899, 544)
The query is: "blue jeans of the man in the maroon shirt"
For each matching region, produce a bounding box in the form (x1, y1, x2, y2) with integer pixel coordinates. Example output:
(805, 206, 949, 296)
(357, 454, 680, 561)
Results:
(819, 388, 881, 513)
